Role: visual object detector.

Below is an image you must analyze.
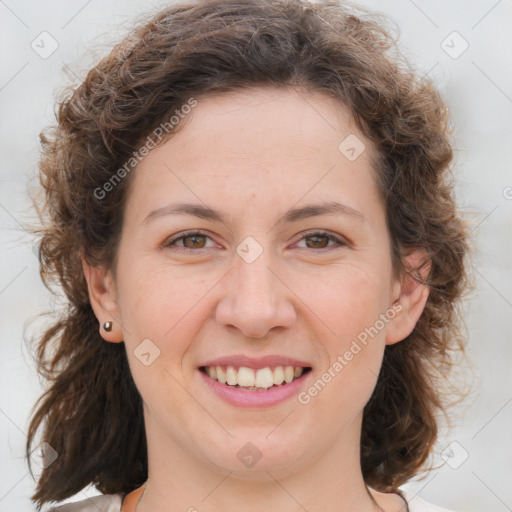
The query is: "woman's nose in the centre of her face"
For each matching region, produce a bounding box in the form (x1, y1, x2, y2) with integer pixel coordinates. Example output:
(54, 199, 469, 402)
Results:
(216, 251, 296, 338)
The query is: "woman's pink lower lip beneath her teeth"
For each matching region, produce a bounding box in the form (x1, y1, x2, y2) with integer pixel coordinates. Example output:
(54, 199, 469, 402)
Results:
(198, 370, 312, 407)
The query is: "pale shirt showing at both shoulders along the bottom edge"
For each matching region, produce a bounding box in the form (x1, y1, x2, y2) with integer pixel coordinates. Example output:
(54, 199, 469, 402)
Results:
(49, 489, 453, 512)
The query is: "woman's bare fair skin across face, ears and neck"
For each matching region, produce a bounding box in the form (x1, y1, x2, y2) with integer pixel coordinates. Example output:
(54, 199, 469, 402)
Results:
(84, 88, 428, 512)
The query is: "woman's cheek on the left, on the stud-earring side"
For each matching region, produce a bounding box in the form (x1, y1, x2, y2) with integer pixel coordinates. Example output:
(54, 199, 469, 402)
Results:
(114, 258, 212, 412)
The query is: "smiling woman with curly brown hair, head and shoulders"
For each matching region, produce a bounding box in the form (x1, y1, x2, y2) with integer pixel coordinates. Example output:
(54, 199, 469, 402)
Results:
(27, 0, 467, 512)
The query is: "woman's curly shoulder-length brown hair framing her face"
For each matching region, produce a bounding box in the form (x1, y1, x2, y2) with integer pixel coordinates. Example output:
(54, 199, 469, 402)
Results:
(26, 0, 469, 510)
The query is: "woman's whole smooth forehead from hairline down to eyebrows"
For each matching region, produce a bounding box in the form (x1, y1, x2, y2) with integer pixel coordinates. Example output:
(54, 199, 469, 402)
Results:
(123, 88, 377, 227)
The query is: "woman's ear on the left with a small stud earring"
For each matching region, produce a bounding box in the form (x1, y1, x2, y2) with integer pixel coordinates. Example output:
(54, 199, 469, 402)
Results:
(82, 256, 124, 343)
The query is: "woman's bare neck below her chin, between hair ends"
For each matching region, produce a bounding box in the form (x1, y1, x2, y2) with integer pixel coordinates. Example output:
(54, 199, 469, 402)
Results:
(136, 412, 384, 512)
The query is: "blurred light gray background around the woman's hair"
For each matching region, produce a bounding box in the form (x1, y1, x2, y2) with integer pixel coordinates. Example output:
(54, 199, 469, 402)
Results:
(0, 0, 512, 512)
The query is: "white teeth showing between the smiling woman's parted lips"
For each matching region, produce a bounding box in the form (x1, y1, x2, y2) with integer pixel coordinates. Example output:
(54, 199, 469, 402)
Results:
(199, 366, 311, 391)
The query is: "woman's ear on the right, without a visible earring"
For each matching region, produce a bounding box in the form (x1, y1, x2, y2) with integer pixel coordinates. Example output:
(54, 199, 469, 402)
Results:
(386, 248, 431, 345)
